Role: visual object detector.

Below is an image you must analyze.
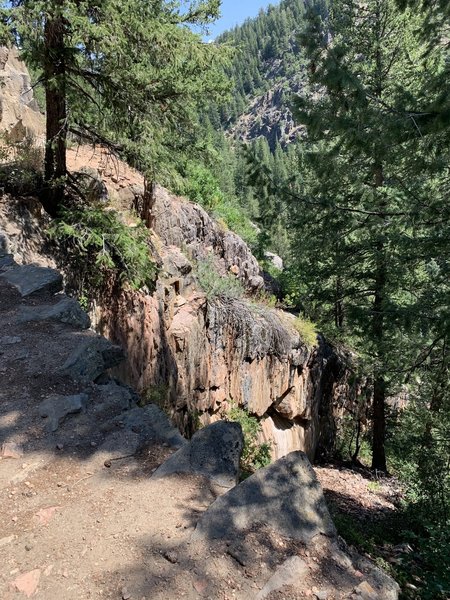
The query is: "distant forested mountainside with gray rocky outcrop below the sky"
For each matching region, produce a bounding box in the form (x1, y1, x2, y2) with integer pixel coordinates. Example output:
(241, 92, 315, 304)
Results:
(218, 0, 305, 151)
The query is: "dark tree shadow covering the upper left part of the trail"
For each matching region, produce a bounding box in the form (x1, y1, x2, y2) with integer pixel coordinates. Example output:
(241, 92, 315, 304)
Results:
(0, 278, 183, 485)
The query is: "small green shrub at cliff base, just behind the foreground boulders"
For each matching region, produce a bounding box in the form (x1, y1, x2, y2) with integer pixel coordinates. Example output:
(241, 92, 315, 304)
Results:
(225, 405, 271, 478)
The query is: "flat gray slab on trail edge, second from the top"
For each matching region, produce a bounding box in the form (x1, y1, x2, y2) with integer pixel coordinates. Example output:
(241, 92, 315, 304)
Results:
(17, 298, 91, 329)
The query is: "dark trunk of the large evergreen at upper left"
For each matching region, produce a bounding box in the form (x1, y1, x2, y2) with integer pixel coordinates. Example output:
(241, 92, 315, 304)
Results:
(43, 0, 68, 216)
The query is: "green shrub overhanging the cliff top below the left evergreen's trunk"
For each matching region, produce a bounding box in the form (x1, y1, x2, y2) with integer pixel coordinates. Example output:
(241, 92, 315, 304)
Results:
(48, 206, 156, 297)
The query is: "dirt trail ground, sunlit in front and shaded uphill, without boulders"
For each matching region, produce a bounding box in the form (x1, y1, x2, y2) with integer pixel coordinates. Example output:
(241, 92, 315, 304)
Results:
(0, 279, 224, 600)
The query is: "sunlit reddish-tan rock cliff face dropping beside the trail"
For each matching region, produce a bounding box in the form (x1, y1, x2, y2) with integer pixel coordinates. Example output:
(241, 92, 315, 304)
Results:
(92, 183, 352, 458)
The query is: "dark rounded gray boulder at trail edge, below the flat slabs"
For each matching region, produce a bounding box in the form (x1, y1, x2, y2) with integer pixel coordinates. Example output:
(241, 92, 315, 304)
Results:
(62, 336, 126, 382)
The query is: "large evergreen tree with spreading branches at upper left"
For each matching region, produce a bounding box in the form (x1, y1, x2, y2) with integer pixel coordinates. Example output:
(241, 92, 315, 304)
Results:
(2, 0, 229, 214)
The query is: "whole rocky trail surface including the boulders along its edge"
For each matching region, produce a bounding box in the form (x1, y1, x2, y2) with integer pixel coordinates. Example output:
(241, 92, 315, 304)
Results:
(0, 253, 398, 600)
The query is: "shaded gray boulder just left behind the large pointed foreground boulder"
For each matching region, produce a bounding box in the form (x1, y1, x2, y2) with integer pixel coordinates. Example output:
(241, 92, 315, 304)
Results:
(153, 421, 244, 488)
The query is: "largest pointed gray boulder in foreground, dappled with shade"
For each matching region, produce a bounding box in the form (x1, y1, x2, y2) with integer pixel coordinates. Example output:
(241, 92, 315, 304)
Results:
(192, 452, 336, 544)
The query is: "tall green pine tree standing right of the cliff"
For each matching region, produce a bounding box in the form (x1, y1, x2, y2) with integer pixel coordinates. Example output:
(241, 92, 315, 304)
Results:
(290, 0, 444, 471)
